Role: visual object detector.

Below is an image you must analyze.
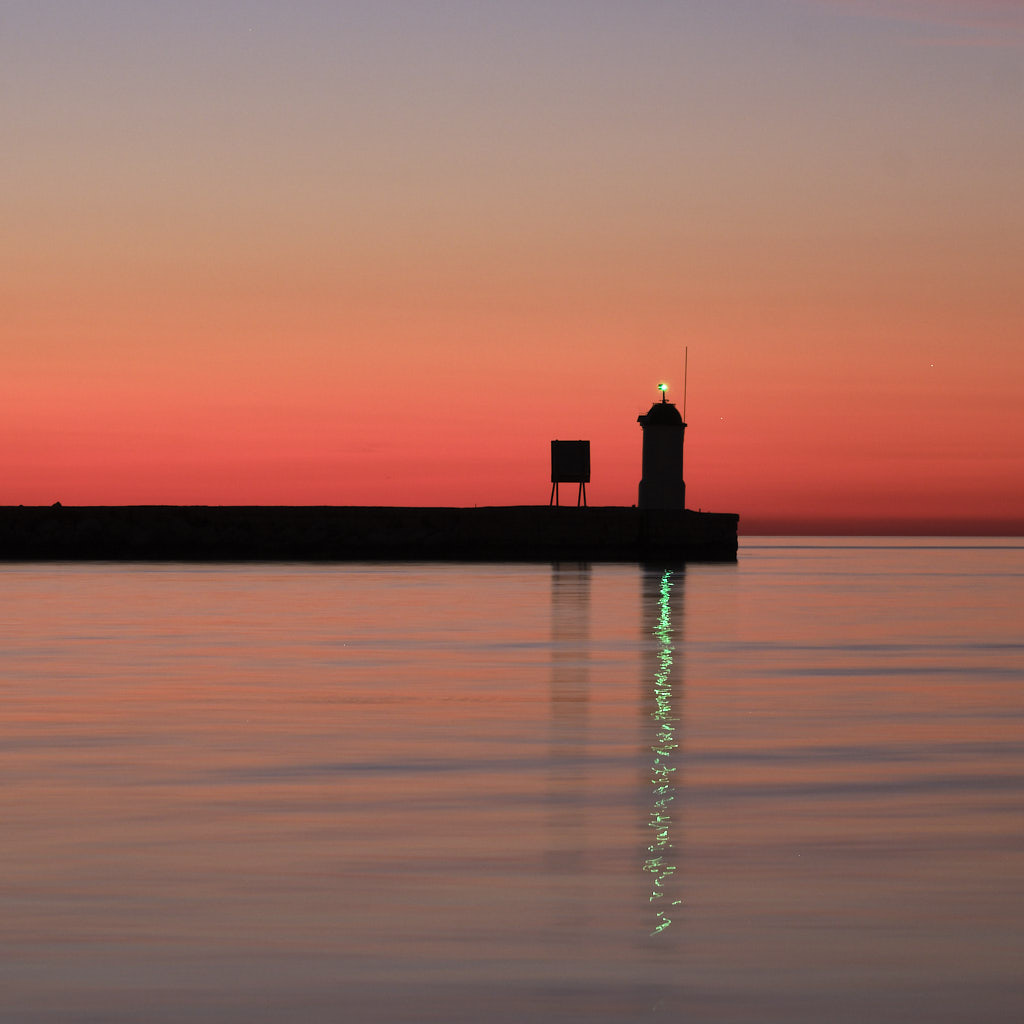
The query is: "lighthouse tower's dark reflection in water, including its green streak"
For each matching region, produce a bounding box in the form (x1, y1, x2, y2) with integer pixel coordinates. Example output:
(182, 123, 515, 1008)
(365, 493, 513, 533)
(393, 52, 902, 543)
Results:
(643, 567, 683, 936)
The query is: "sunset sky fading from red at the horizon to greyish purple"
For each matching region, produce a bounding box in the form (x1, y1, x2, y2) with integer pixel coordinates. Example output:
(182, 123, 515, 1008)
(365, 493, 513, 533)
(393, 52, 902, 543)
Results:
(0, 0, 1024, 534)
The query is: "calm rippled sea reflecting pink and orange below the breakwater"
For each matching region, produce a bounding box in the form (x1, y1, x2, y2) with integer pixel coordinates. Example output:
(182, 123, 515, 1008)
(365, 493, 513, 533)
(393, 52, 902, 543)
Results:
(0, 540, 1024, 1024)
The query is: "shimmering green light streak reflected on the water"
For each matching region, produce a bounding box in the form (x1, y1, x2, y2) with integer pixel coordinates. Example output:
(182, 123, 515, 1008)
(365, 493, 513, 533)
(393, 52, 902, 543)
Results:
(643, 569, 682, 935)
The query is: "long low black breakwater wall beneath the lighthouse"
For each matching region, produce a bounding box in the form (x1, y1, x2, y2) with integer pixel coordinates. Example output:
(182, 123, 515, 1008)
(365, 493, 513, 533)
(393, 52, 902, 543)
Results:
(0, 505, 739, 561)
